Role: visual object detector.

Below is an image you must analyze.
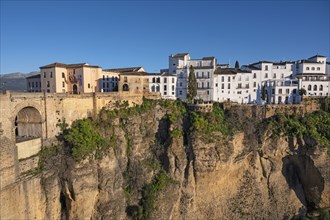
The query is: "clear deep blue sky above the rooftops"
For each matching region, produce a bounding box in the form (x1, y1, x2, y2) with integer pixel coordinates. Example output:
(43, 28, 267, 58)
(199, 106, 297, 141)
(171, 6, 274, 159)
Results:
(0, 0, 330, 73)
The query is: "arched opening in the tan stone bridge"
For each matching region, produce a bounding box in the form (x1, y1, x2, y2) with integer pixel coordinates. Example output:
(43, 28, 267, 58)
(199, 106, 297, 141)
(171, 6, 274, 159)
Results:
(14, 106, 43, 139)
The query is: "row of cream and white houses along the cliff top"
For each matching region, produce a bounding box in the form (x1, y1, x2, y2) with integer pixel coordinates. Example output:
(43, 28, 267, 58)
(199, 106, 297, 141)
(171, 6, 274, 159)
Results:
(27, 53, 330, 104)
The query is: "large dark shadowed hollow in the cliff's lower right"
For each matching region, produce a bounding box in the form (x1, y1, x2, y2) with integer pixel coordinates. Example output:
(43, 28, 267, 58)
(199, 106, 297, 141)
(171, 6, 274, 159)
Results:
(282, 155, 324, 211)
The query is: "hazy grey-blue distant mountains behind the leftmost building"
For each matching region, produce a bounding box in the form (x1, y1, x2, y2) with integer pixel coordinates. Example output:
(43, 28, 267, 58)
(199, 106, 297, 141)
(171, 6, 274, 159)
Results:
(0, 71, 39, 91)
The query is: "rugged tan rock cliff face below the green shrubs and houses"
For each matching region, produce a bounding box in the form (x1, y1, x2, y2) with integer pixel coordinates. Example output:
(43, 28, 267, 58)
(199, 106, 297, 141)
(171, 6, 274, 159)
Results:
(1, 101, 330, 219)
